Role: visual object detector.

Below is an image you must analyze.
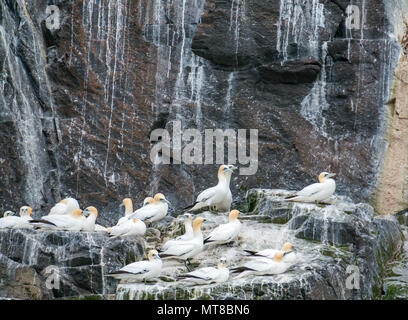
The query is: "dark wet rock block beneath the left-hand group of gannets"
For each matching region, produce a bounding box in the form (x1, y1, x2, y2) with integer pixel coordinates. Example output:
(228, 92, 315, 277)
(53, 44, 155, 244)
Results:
(0, 229, 145, 299)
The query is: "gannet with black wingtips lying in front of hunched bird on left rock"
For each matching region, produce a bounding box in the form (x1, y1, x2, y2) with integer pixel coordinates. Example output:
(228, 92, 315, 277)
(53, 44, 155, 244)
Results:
(30, 209, 85, 231)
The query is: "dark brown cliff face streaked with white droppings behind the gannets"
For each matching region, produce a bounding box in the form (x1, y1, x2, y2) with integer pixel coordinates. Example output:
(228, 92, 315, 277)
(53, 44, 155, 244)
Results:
(0, 0, 406, 224)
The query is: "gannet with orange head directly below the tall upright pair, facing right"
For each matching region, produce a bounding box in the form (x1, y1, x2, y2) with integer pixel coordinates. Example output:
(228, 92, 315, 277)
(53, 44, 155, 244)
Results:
(204, 210, 241, 244)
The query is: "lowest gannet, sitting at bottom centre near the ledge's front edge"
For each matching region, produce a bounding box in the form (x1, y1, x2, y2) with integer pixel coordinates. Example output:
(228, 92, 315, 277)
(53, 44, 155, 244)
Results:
(177, 257, 229, 284)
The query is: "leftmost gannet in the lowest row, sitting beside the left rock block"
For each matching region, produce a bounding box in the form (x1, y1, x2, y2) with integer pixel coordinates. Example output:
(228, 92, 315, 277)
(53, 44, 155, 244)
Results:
(108, 250, 162, 282)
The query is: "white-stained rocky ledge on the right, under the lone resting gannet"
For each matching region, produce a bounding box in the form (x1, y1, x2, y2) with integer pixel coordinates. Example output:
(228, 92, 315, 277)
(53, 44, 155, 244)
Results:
(116, 189, 404, 299)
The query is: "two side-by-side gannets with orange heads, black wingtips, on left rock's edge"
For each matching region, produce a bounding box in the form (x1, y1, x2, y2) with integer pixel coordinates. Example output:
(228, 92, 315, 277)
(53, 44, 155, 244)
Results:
(30, 206, 98, 232)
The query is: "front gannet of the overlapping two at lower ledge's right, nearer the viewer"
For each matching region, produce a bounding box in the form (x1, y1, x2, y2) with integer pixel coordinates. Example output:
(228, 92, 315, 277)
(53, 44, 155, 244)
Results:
(231, 251, 292, 279)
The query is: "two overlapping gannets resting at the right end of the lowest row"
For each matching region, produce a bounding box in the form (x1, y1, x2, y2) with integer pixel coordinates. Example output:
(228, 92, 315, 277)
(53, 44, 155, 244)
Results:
(231, 242, 297, 279)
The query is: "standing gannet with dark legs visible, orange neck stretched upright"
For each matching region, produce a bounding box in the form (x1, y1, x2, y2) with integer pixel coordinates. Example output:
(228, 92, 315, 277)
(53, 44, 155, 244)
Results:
(160, 217, 204, 271)
